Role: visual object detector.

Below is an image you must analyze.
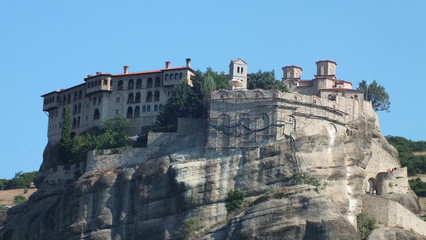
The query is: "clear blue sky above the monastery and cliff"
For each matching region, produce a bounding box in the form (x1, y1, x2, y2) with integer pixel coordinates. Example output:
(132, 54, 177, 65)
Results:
(0, 0, 426, 178)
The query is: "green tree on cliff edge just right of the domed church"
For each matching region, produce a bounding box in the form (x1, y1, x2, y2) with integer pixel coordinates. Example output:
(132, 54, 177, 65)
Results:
(358, 80, 391, 112)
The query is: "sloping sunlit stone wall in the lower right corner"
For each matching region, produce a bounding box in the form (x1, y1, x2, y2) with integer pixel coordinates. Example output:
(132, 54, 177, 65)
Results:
(362, 194, 426, 236)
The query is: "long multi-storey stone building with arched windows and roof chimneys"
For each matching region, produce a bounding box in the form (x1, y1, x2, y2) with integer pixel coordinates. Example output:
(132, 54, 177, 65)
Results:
(42, 58, 194, 143)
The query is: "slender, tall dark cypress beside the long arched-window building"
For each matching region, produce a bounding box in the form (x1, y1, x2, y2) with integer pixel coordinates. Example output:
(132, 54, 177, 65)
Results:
(59, 106, 72, 162)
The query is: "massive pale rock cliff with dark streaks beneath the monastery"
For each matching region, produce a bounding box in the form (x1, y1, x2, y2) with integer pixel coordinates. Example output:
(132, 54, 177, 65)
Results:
(0, 113, 420, 240)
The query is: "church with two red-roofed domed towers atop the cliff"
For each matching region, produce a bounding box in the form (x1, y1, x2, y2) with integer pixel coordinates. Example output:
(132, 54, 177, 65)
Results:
(282, 60, 364, 100)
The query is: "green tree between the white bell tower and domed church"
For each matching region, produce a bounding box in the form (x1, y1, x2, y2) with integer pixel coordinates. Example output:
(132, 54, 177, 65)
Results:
(247, 70, 288, 92)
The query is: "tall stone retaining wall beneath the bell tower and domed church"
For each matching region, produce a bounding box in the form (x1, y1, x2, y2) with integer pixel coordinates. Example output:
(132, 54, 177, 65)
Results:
(208, 89, 370, 148)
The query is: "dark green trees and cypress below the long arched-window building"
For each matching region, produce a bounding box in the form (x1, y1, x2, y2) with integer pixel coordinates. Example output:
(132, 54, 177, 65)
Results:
(58, 114, 134, 163)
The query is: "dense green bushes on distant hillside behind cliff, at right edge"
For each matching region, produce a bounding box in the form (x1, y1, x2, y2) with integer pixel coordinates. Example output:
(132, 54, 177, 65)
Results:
(386, 136, 426, 176)
